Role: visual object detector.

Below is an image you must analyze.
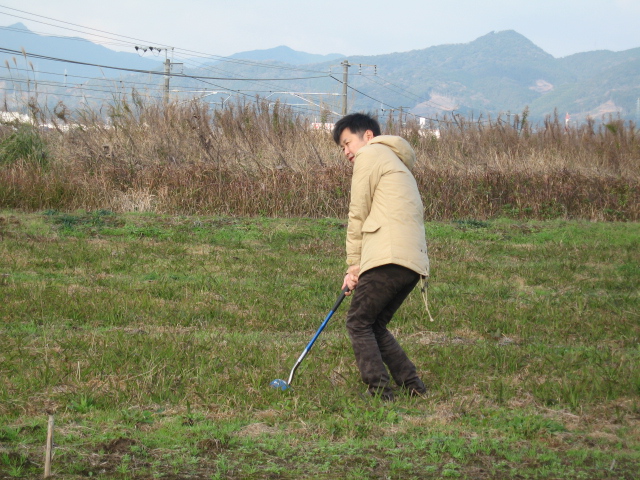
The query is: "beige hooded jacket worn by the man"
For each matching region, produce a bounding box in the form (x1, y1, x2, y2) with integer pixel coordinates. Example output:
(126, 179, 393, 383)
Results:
(347, 135, 429, 276)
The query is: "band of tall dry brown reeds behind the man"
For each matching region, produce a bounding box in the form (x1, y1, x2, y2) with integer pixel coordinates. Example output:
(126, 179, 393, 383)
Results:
(0, 96, 640, 220)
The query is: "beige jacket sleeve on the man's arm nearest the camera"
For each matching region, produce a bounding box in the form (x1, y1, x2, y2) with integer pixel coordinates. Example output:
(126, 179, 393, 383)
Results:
(347, 147, 380, 265)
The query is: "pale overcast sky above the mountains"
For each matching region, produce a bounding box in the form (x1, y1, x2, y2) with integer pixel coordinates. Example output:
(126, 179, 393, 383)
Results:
(0, 0, 640, 57)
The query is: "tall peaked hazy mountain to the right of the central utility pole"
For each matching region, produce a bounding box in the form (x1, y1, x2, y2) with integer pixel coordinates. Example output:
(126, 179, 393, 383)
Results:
(330, 31, 640, 120)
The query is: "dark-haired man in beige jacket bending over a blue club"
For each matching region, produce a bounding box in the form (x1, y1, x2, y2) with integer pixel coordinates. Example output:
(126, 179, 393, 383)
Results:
(333, 113, 429, 401)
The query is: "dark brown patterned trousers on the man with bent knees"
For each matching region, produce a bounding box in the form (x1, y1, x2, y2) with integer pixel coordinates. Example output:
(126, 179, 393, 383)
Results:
(347, 264, 424, 398)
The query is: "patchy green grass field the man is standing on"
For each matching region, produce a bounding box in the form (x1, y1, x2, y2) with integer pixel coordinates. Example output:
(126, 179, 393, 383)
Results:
(0, 211, 640, 479)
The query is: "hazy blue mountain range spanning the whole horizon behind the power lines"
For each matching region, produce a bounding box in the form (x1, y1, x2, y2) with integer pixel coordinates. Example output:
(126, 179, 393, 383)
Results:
(0, 24, 640, 121)
